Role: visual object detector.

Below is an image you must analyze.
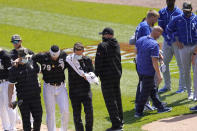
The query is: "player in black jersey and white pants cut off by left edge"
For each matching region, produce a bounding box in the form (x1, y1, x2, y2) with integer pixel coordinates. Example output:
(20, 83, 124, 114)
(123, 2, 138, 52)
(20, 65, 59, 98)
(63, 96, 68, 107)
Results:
(0, 48, 16, 131)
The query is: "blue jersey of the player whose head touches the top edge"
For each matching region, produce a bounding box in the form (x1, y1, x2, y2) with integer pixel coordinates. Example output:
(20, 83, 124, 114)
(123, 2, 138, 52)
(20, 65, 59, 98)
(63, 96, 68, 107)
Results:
(158, 7, 183, 45)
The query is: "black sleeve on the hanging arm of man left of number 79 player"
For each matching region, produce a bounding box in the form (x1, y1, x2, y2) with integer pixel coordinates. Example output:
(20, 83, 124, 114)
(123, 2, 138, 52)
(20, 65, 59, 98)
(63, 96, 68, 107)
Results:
(8, 67, 18, 84)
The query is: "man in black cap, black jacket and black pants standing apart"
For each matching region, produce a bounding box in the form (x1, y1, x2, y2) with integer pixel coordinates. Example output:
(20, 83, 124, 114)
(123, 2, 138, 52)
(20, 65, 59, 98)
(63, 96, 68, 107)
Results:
(95, 28, 123, 131)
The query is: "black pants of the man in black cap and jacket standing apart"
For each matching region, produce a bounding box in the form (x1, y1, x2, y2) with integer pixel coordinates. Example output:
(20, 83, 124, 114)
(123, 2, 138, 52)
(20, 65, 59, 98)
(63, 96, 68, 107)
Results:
(101, 78, 123, 128)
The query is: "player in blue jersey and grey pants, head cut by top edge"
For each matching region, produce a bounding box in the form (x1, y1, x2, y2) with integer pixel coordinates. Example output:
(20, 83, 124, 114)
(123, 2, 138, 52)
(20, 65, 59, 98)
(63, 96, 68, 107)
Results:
(158, 0, 185, 93)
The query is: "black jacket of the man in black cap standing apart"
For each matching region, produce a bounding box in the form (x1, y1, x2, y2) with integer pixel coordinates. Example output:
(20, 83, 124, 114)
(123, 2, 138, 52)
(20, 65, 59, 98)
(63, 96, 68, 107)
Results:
(95, 38, 122, 81)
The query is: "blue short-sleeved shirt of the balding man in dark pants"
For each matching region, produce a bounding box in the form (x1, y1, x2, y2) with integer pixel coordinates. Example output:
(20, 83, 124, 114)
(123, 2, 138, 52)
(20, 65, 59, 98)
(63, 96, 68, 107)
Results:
(136, 36, 159, 76)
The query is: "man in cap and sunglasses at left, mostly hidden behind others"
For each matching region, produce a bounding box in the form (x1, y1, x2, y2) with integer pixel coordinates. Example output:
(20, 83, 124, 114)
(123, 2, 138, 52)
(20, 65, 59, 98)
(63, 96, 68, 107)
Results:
(10, 34, 34, 61)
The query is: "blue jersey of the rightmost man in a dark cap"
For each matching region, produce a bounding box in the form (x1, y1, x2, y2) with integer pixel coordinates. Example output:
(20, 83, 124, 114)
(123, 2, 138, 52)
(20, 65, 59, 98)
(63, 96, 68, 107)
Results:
(166, 14, 197, 46)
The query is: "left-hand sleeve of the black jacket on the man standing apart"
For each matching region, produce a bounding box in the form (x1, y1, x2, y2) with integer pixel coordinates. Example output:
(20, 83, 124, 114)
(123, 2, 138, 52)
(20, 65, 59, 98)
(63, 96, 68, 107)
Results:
(95, 44, 105, 76)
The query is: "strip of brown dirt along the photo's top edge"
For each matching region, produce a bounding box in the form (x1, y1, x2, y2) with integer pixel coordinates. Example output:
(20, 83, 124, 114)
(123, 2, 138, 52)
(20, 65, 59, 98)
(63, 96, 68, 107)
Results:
(78, 0, 197, 11)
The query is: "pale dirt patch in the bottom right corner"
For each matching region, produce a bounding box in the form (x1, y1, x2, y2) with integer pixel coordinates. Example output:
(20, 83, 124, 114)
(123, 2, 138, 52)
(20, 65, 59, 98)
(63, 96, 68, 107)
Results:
(142, 114, 197, 131)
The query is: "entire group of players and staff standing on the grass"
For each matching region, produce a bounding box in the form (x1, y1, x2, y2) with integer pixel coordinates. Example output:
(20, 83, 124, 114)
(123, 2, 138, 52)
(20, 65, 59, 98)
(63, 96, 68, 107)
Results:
(0, 0, 197, 131)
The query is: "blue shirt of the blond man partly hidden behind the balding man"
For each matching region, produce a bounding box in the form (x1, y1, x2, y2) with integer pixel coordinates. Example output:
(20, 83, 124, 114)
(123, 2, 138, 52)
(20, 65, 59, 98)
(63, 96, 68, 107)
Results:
(135, 20, 152, 41)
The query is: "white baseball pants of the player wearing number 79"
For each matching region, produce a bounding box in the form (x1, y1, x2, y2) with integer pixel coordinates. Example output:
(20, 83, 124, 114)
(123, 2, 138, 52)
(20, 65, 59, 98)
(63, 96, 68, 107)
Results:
(43, 83, 69, 131)
